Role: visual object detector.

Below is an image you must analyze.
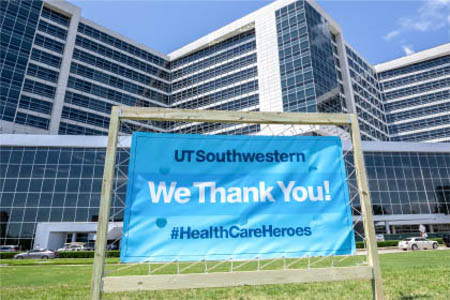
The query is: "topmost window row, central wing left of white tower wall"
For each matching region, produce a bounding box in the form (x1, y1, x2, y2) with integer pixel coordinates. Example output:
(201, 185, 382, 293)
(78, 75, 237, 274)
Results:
(170, 29, 255, 69)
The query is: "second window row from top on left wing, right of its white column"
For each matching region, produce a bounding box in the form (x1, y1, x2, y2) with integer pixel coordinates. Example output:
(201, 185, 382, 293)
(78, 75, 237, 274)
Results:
(75, 35, 169, 80)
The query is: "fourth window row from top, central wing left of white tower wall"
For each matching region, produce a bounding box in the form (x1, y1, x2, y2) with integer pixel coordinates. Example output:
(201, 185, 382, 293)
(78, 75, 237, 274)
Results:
(171, 67, 258, 102)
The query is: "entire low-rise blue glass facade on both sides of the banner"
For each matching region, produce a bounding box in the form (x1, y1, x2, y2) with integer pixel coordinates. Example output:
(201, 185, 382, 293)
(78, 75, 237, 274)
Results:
(0, 143, 450, 247)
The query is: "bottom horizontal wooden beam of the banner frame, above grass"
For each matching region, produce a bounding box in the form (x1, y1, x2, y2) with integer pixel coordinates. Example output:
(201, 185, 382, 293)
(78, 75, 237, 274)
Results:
(103, 267, 373, 292)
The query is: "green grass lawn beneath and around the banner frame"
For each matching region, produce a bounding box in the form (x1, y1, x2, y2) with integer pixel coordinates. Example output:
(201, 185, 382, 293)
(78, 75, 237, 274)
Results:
(0, 251, 450, 300)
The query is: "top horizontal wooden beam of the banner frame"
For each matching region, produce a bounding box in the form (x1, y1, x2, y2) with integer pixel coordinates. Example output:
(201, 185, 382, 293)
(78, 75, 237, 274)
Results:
(120, 106, 352, 125)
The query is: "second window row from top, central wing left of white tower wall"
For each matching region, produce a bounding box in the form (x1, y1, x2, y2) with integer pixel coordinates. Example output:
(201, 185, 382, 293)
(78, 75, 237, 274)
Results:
(170, 41, 256, 81)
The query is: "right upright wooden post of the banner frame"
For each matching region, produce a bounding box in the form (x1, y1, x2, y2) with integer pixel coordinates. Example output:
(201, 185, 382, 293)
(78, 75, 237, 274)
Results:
(351, 114, 384, 300)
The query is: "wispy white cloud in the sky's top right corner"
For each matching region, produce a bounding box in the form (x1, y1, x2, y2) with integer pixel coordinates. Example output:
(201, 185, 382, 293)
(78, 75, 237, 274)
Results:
(383, 0, 450, 41)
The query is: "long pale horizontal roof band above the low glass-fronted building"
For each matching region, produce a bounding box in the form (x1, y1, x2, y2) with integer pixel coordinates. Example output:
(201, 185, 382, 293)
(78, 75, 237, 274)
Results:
(0, 134, 450, 153)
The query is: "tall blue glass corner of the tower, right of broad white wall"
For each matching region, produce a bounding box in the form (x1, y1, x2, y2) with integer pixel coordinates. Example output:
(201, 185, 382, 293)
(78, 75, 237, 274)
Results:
(275, 1, 346, 112)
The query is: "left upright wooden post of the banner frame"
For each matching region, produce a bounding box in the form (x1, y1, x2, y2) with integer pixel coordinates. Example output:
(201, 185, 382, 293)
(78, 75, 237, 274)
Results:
(91, 106, 120, 300)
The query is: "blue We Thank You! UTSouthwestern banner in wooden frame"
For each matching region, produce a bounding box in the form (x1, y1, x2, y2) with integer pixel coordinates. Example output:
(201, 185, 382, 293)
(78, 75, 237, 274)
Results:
(120, 133, 355, 262)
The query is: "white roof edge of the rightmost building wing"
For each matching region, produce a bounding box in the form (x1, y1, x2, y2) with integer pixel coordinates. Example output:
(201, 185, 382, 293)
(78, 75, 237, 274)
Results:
(374, 43, 450, 73)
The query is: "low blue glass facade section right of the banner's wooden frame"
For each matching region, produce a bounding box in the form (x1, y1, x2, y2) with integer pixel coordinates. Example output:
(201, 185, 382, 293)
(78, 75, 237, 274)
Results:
(347, 152, 450, 215)
